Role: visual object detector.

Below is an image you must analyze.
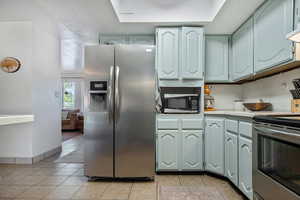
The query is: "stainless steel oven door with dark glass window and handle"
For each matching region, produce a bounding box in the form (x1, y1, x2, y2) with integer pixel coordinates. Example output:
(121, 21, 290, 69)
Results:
(253, 124, 300, 200)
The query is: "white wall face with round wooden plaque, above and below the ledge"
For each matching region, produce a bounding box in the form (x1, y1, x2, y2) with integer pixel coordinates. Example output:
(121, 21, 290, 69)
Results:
(0, 21, 33, 157)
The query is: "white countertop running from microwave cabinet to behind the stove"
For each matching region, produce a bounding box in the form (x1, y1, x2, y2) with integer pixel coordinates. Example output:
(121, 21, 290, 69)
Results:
(204, 110, 300, 118)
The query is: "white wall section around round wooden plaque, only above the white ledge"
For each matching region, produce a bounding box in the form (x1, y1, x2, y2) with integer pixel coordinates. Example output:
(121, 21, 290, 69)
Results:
(0, 21, 33, 114)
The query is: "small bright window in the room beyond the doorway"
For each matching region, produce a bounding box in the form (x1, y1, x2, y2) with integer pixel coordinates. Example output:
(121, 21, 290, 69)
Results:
(63, 81, 75, 109)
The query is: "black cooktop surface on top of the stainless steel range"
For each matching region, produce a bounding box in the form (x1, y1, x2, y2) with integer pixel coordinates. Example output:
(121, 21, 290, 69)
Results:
(253, 115, 300, 128)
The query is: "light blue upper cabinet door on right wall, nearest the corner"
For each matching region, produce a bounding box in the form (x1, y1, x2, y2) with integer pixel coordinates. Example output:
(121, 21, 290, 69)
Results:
(232, 18, 253, 80)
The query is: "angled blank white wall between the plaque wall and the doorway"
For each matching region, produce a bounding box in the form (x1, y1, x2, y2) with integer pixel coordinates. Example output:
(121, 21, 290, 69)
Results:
(32, 17, 61, 156)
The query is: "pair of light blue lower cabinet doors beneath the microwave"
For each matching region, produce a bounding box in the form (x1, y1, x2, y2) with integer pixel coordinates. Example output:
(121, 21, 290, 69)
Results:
(156, 130, 203, 171)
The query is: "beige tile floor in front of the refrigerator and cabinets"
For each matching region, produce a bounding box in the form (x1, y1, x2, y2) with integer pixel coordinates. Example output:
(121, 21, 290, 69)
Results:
(0, 136, 243, 200)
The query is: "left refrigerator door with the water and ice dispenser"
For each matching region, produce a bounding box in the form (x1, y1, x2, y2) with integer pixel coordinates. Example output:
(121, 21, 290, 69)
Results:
(84, 46, 114, 177)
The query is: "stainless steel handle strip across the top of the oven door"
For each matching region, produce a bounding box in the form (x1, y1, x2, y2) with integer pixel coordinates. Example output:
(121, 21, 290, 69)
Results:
(254, 127, 300, 144)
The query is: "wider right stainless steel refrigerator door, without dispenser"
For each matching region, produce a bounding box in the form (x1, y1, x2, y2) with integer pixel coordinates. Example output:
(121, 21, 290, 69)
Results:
(115, 45, 155, 178)
